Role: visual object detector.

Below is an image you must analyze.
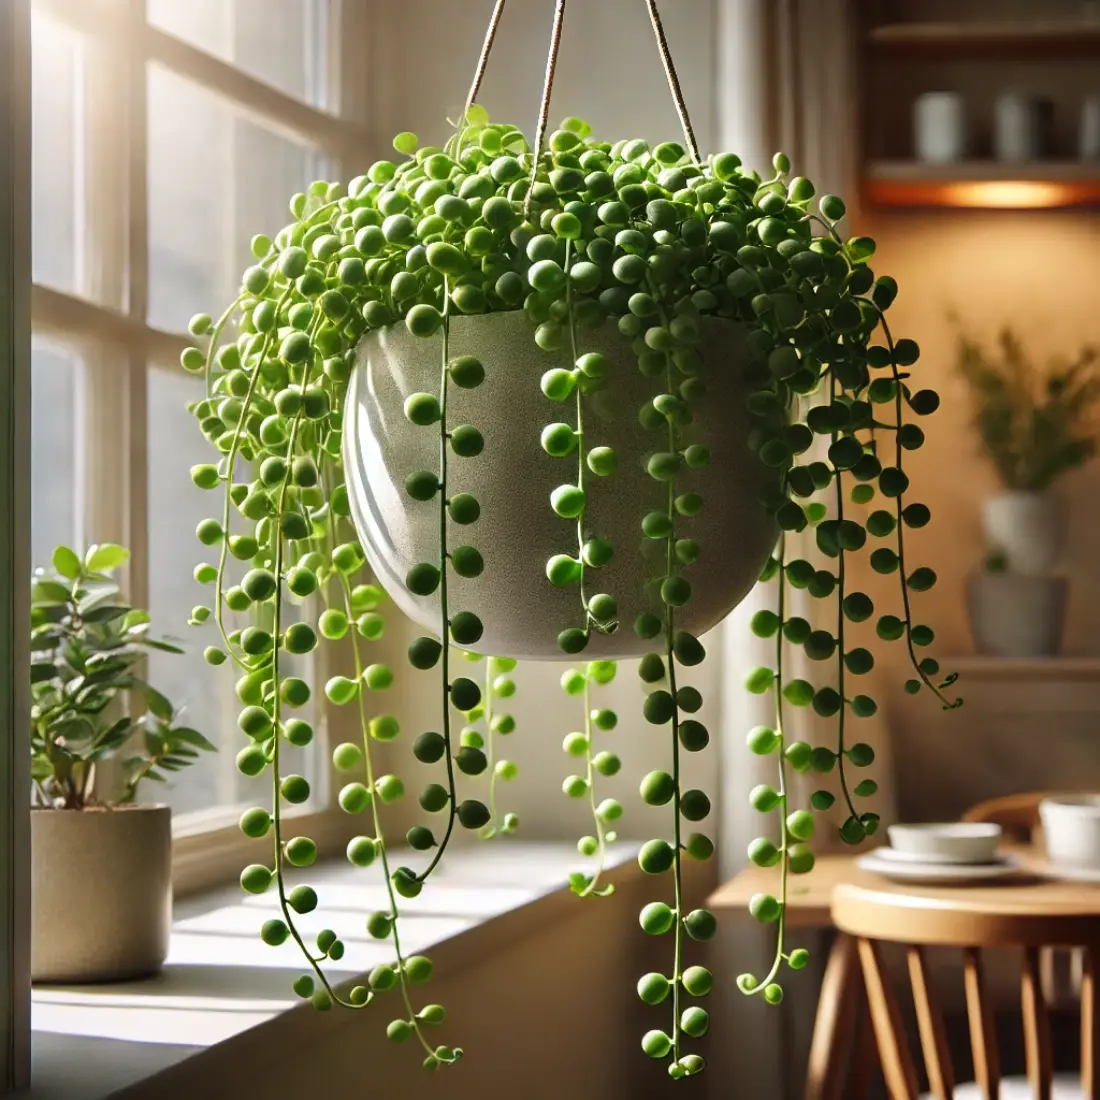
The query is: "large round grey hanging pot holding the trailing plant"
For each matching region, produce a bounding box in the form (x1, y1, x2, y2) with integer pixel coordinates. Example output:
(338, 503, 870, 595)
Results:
(343, 312, 777, 660)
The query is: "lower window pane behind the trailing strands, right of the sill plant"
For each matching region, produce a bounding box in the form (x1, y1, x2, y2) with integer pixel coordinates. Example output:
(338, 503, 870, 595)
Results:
(145, 369, 325, 814)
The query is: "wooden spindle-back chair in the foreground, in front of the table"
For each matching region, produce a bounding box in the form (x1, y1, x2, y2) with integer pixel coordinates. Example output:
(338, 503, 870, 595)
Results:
(833, 886, 1100, 1100)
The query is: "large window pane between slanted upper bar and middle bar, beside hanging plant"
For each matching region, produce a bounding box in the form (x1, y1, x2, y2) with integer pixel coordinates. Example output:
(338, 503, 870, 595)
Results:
(149, 66, 331, 331)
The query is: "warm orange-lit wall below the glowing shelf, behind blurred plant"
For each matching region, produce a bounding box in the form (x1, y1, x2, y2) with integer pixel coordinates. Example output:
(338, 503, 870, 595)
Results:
(859, 210, 1100, 812)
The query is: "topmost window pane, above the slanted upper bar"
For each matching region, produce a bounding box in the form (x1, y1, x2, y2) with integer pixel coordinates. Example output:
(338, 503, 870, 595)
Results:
(145, 0, 329, 107)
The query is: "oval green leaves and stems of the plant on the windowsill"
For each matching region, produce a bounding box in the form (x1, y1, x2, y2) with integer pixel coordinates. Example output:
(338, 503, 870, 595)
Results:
(31, 543, 213, 810)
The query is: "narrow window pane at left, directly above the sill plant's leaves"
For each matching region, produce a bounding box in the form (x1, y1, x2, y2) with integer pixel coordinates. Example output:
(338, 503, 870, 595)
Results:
(31, 339, 80, 567)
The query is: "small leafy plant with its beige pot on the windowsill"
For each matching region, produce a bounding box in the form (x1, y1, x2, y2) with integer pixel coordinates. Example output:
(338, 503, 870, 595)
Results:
(31, 543, 213, 982)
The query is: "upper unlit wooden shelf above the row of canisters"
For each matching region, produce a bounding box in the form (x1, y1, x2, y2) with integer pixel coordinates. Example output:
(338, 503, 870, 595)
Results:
(867, 20, 1100, 61)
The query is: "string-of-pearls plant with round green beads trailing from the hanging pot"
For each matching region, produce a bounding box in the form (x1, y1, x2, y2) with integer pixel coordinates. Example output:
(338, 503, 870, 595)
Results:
(182, 2, 956, 1078)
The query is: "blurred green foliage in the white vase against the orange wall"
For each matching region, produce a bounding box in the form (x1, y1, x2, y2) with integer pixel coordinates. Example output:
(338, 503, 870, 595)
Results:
(958, 328, 1100, 492)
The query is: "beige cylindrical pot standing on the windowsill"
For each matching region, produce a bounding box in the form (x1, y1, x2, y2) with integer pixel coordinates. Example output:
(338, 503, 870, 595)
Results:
(31, 806, 172, 982)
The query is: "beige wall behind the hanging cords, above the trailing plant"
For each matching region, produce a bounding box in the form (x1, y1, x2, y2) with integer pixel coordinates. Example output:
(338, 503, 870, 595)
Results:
(372, 0, 718, 154)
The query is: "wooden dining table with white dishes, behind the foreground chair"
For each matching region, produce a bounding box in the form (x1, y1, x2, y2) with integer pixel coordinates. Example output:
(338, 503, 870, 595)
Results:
(707, 846, 1100, 1100)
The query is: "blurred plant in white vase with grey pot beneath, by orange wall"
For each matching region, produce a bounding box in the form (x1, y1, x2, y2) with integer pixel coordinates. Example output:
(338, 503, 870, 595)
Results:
(958, 328, 1100, 657)
